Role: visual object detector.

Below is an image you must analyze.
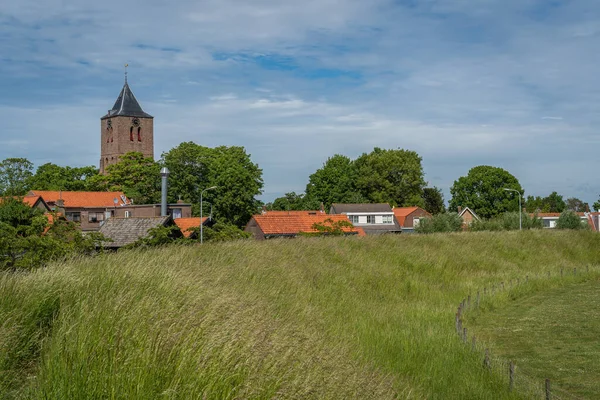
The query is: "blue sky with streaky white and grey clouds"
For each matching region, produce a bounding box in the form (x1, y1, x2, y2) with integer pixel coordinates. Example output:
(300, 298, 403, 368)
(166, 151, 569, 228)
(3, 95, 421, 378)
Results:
(0, 0, 600, 204)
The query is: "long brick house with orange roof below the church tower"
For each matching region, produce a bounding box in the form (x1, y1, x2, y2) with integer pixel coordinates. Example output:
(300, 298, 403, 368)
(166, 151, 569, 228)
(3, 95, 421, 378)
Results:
(24, 190, 192, 232)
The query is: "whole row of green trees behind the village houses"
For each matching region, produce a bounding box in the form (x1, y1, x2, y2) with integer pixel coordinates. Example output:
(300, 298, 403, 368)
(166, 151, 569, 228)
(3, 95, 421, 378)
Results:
(0, 142, 600, 228)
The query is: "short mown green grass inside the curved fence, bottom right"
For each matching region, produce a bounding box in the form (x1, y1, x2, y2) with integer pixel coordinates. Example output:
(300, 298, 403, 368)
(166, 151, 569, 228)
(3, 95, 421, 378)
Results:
(469, 276, 600, 399)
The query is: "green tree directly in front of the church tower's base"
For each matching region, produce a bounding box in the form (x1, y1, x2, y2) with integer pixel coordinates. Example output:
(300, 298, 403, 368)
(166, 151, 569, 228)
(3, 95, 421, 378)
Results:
(88, 152, 161, 204)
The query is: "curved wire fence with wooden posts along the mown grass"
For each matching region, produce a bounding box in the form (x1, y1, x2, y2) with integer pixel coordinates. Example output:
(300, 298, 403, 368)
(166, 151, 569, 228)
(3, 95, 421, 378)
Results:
(455, 265, 595, 400)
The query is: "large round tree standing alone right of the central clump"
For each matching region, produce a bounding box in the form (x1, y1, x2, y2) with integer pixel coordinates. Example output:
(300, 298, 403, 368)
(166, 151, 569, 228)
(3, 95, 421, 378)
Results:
(449, 165, 523, 218)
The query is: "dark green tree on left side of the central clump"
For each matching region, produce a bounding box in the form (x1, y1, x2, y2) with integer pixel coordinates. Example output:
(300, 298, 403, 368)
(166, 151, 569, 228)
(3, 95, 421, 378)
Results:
(305, 154, 360, 209)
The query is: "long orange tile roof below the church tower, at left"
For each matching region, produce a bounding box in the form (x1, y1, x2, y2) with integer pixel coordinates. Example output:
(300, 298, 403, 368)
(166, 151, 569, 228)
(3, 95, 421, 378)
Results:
(25, 190, 131, 208)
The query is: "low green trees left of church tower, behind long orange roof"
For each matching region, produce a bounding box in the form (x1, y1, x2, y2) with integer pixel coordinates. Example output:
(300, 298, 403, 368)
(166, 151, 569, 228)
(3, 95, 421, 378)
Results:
(28, 163, 98, 191)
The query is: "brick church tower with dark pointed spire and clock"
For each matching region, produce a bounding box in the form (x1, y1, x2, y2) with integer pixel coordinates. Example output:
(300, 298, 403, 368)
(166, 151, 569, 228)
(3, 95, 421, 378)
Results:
(100, 76, 154, 174)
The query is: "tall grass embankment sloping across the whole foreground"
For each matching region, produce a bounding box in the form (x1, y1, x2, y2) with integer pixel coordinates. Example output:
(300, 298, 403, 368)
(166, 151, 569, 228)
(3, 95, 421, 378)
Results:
(0, 231, 600, 399)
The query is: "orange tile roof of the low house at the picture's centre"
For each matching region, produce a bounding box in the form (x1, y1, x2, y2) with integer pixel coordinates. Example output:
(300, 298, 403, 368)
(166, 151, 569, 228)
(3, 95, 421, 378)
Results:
(252, 214, 359, 235)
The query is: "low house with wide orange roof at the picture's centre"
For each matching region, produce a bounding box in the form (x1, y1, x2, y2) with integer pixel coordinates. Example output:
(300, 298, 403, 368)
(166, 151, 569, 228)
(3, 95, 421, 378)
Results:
(244, 214, 364, 240)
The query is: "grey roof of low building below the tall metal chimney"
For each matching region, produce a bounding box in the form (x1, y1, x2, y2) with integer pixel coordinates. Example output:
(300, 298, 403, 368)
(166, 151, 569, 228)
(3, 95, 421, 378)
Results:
(100, 216, 172, 248)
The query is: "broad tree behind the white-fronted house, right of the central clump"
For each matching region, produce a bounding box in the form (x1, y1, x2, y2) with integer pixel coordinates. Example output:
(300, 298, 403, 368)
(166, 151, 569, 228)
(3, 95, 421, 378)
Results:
(354, 147, 425, 206)
